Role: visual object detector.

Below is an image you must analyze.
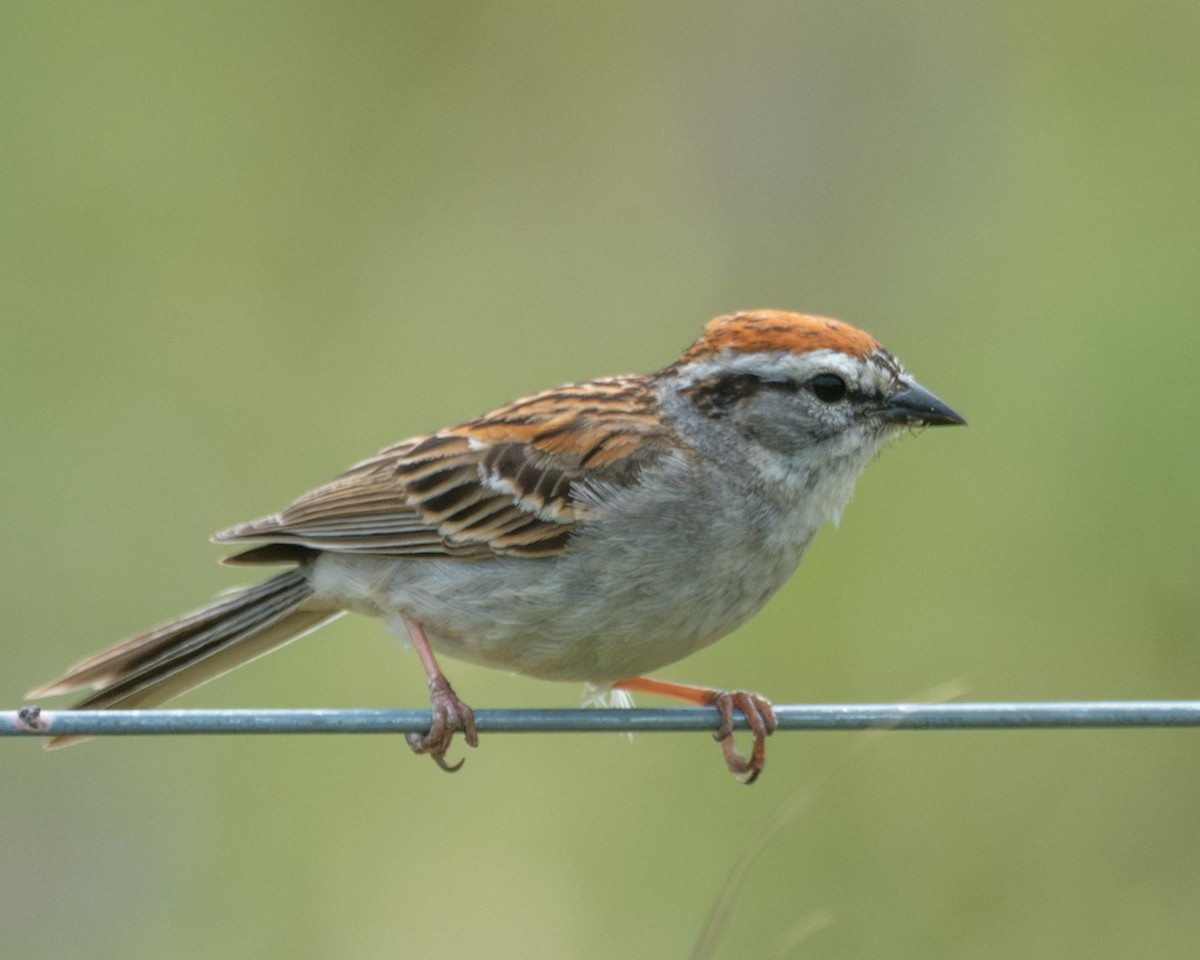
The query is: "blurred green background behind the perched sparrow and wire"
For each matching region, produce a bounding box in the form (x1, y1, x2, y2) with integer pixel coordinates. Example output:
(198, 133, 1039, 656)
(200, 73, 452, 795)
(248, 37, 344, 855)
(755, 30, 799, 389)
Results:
(0, 0, 1200, 960)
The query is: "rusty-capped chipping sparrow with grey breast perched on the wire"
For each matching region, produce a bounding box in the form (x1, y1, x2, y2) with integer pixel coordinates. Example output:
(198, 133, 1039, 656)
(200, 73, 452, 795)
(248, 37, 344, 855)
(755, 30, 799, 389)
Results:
(29, 310, 964, 782)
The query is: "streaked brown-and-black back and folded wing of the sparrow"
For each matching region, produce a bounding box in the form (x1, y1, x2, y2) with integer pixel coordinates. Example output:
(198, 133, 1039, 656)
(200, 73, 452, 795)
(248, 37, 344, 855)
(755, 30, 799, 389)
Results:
(214, 377, 667, 563)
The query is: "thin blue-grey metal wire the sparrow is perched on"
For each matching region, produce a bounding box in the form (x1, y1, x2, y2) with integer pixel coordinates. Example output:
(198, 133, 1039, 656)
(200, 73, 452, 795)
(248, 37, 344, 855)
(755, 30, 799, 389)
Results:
(7, 701, 1200, 737)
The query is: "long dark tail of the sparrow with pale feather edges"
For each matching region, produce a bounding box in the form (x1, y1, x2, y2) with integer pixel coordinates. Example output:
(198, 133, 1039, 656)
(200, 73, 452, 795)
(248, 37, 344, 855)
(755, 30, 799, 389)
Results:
(25, 569, 342, 750)
